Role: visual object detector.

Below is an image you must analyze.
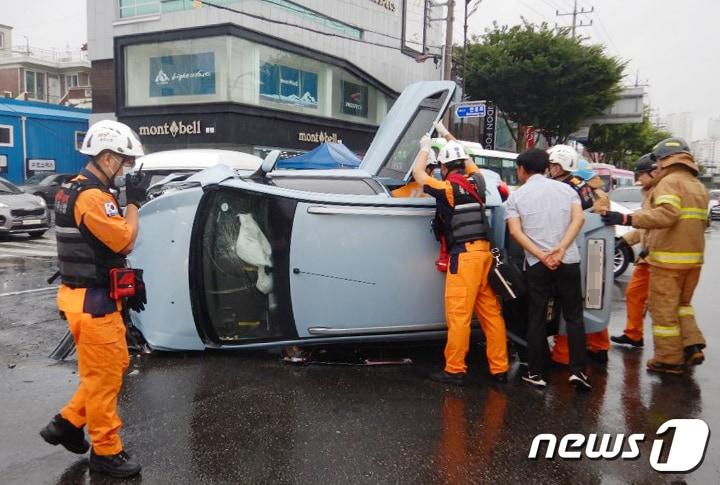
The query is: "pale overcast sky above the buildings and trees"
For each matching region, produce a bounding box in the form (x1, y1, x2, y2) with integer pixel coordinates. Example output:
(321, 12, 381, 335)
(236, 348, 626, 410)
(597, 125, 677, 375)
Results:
(0, 0, 720, 138)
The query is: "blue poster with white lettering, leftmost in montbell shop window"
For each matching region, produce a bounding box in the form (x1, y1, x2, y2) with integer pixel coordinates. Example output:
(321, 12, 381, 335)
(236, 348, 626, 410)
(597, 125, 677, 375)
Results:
(150, 52, 215, 97)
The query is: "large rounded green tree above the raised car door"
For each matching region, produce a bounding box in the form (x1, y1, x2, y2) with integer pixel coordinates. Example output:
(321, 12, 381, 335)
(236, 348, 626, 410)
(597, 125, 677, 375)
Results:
(465, 23, 625, 143)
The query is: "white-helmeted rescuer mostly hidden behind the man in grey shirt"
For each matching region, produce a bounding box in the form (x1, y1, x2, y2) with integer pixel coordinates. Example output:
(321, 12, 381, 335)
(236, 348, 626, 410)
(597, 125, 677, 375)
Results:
(548, 145, 610, 365)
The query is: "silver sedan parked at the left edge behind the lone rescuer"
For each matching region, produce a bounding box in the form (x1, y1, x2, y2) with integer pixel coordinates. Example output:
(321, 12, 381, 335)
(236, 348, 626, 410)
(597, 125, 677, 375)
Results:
(0, 177, 50, 238)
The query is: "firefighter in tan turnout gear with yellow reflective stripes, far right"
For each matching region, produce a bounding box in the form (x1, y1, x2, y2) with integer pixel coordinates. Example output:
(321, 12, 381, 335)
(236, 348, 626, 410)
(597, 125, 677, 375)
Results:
(603, 138, 709, 374)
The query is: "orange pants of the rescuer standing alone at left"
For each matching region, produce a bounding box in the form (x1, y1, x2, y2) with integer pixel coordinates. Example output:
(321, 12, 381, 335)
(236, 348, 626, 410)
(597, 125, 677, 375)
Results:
(60, 312, 129, 455)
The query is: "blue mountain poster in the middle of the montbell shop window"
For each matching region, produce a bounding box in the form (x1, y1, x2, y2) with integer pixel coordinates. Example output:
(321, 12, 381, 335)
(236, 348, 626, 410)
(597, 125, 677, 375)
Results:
(260, 62, 318, 108)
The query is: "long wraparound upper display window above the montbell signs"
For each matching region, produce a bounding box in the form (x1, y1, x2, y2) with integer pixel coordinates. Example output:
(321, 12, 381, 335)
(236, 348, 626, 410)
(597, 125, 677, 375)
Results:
(125, 36, 390, 125)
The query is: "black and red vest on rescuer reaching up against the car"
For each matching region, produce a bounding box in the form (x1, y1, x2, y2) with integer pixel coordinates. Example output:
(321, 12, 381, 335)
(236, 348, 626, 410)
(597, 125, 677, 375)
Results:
(434, 173, 490, 250)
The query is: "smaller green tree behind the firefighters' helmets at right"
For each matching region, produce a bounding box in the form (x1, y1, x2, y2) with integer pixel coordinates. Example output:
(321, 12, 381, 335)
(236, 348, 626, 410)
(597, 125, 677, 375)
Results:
(585, 108, 672, 168)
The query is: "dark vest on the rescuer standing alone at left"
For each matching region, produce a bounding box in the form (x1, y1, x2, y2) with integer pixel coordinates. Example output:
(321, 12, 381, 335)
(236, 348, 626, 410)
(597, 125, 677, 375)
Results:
(55, 174, 126, 288)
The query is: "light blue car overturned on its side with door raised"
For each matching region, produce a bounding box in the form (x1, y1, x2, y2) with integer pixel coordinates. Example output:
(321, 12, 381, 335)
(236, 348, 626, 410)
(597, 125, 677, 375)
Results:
(130, 81, 614, 350)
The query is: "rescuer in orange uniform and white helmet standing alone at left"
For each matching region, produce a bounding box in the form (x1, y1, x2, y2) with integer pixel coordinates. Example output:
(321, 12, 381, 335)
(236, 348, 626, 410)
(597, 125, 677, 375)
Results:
(40, 120, 150, 477)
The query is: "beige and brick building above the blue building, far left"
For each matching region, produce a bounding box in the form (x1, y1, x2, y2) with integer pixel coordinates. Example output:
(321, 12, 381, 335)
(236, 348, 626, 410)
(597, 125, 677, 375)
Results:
(0, 25, 92, 107)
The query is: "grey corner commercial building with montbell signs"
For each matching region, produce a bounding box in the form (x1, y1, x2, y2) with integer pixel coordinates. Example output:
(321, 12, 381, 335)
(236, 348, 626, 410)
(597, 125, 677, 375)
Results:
(88, 0, 443, 155)
